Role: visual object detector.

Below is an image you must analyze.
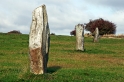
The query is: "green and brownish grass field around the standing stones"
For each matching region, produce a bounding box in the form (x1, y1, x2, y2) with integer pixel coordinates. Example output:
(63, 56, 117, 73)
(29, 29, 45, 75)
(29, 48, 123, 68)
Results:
(0, 34, 124, 82)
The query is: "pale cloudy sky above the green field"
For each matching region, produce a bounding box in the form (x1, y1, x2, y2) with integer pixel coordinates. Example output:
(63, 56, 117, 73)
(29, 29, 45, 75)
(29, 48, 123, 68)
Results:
(0, 0, 124, 35)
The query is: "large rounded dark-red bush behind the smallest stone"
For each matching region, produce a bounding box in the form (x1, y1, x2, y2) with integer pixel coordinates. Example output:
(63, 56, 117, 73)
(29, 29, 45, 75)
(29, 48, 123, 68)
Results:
(85, 18, 116, 35)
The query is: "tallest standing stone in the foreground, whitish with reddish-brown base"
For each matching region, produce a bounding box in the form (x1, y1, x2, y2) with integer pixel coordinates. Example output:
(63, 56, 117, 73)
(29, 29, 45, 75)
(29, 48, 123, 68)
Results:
(29, 5, 50, 74)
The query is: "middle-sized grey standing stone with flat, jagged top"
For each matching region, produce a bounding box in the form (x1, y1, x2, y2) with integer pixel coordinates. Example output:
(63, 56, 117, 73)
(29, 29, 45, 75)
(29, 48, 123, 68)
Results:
(75, 24, 84, 51)
